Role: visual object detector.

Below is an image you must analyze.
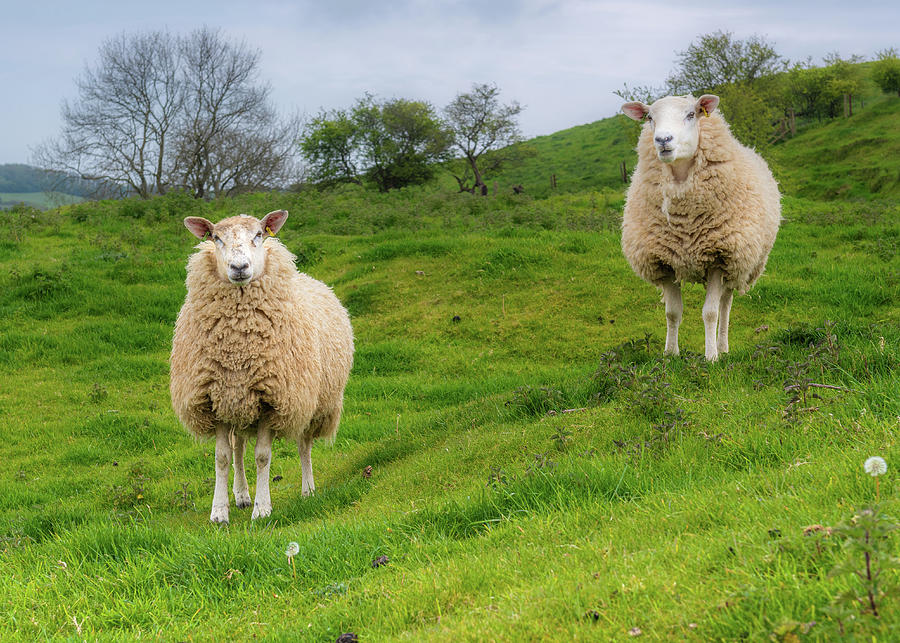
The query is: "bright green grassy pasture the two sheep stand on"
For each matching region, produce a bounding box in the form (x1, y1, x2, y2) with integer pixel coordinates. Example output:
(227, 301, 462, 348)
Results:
(0, 188, 900, 641)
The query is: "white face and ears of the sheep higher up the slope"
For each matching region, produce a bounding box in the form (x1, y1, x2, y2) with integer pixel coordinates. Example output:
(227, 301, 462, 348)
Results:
(622, 94, 719, 163)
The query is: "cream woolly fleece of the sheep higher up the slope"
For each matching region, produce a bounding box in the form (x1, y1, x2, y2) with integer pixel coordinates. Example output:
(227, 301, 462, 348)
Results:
(622, 112, 781, 293)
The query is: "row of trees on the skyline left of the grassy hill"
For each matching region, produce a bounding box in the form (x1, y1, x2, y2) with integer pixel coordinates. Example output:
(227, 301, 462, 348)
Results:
(34, 27, 527, 198)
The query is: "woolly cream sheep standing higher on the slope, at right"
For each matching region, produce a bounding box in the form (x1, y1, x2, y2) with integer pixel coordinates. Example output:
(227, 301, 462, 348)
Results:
(622, 94, 781, 361)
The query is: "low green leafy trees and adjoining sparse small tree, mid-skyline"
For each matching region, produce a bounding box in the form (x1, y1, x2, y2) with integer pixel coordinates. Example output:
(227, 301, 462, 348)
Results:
(300, 84, 530, 194)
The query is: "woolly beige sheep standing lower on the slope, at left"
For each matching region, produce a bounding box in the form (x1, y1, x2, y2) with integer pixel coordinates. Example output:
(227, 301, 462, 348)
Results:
(170, 210, 353, 523)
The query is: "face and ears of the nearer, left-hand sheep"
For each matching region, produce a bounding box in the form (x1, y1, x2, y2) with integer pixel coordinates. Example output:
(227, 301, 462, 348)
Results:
(184, 210, 288, 286)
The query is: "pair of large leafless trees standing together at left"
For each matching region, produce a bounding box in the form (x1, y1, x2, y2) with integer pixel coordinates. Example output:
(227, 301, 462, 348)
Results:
(33, 28, 299, 198)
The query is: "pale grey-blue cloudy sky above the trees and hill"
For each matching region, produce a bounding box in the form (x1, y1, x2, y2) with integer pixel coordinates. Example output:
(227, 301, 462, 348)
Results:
(0, 0, 900, 163)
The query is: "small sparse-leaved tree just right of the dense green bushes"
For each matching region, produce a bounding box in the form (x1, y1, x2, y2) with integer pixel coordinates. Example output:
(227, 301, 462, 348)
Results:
(444, 84, 525, 194)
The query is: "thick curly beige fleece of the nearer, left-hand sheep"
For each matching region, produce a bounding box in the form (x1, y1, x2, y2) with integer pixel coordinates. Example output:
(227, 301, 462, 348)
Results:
(170, 238, 353, 439)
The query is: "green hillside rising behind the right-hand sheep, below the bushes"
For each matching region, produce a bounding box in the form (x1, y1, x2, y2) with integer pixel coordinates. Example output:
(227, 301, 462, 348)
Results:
(488, 64, 900, 199)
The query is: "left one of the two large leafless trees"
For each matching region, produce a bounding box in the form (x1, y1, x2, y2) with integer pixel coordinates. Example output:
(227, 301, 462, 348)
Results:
(34, 31, 182, 198)
